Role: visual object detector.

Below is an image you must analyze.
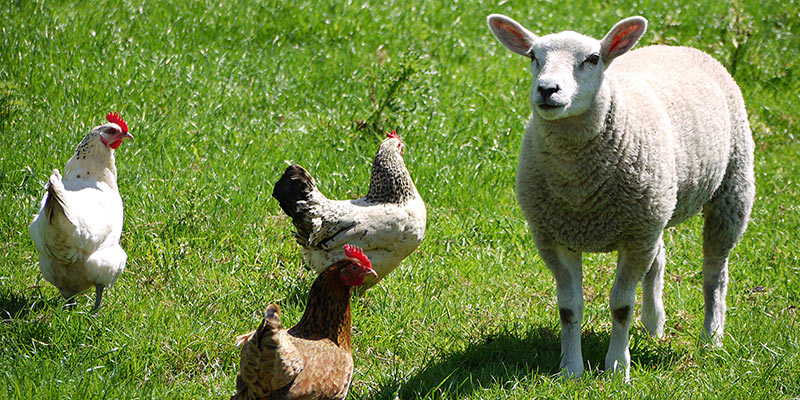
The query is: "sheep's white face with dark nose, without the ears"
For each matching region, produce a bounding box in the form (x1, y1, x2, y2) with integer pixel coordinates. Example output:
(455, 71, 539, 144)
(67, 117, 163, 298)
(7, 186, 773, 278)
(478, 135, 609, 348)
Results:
(528, 32, 603, 120)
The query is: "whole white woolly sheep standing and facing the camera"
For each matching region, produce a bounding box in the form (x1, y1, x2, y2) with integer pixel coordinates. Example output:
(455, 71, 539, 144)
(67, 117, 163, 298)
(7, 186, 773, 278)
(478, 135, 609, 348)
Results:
(487, 14, 755, 381)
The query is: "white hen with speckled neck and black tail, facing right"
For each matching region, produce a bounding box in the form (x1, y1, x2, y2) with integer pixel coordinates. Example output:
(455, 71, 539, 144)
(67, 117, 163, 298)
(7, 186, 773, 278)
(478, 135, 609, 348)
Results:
(272, 131, 427, 289)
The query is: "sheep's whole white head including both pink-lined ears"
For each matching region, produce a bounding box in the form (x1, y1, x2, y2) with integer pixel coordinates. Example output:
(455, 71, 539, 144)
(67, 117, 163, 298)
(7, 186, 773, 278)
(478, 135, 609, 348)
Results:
(487, 14, 647, 120)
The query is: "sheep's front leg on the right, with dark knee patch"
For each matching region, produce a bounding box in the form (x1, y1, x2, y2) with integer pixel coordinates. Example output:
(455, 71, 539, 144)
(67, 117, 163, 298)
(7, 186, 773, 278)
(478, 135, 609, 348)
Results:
(606, 244, 660, 382)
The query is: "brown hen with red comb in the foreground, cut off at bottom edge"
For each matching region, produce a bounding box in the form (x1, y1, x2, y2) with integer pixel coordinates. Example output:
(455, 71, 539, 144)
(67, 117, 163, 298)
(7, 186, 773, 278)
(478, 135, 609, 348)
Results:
(231, 245, 376, 400)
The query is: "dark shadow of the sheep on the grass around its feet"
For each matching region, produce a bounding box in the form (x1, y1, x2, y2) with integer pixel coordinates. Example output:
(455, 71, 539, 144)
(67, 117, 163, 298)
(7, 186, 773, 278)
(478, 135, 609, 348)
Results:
(372, 327, 678, 399)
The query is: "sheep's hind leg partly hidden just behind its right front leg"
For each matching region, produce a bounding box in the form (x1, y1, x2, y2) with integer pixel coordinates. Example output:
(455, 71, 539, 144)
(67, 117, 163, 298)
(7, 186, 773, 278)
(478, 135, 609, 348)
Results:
(641, 238, 667, 338)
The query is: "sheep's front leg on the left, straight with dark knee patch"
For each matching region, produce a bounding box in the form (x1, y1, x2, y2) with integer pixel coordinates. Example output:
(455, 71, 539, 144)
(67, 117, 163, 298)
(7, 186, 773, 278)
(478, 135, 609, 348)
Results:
(539, 246, 583, 378)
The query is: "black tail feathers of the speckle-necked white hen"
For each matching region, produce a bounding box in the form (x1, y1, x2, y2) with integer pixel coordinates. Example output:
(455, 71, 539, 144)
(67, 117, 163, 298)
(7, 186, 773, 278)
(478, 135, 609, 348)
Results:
(272, 164, 324, 246)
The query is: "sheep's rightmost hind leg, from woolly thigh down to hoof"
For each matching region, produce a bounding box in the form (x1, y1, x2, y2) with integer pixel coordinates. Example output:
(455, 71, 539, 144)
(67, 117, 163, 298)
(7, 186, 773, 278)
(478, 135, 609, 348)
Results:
(703, 168, 755, 346)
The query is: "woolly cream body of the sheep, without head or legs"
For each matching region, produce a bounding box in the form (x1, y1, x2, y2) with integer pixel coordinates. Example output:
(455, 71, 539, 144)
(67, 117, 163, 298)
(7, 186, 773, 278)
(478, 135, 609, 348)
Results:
(517, 46, 749, 251)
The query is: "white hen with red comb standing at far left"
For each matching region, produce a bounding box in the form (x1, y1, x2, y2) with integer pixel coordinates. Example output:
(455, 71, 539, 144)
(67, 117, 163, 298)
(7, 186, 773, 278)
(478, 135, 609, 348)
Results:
(28, 113, 133, 309)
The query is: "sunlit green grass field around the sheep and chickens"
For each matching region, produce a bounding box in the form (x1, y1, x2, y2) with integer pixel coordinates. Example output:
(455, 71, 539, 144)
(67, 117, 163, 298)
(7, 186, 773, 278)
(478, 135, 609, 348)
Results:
(0, 0, 800, 399)
